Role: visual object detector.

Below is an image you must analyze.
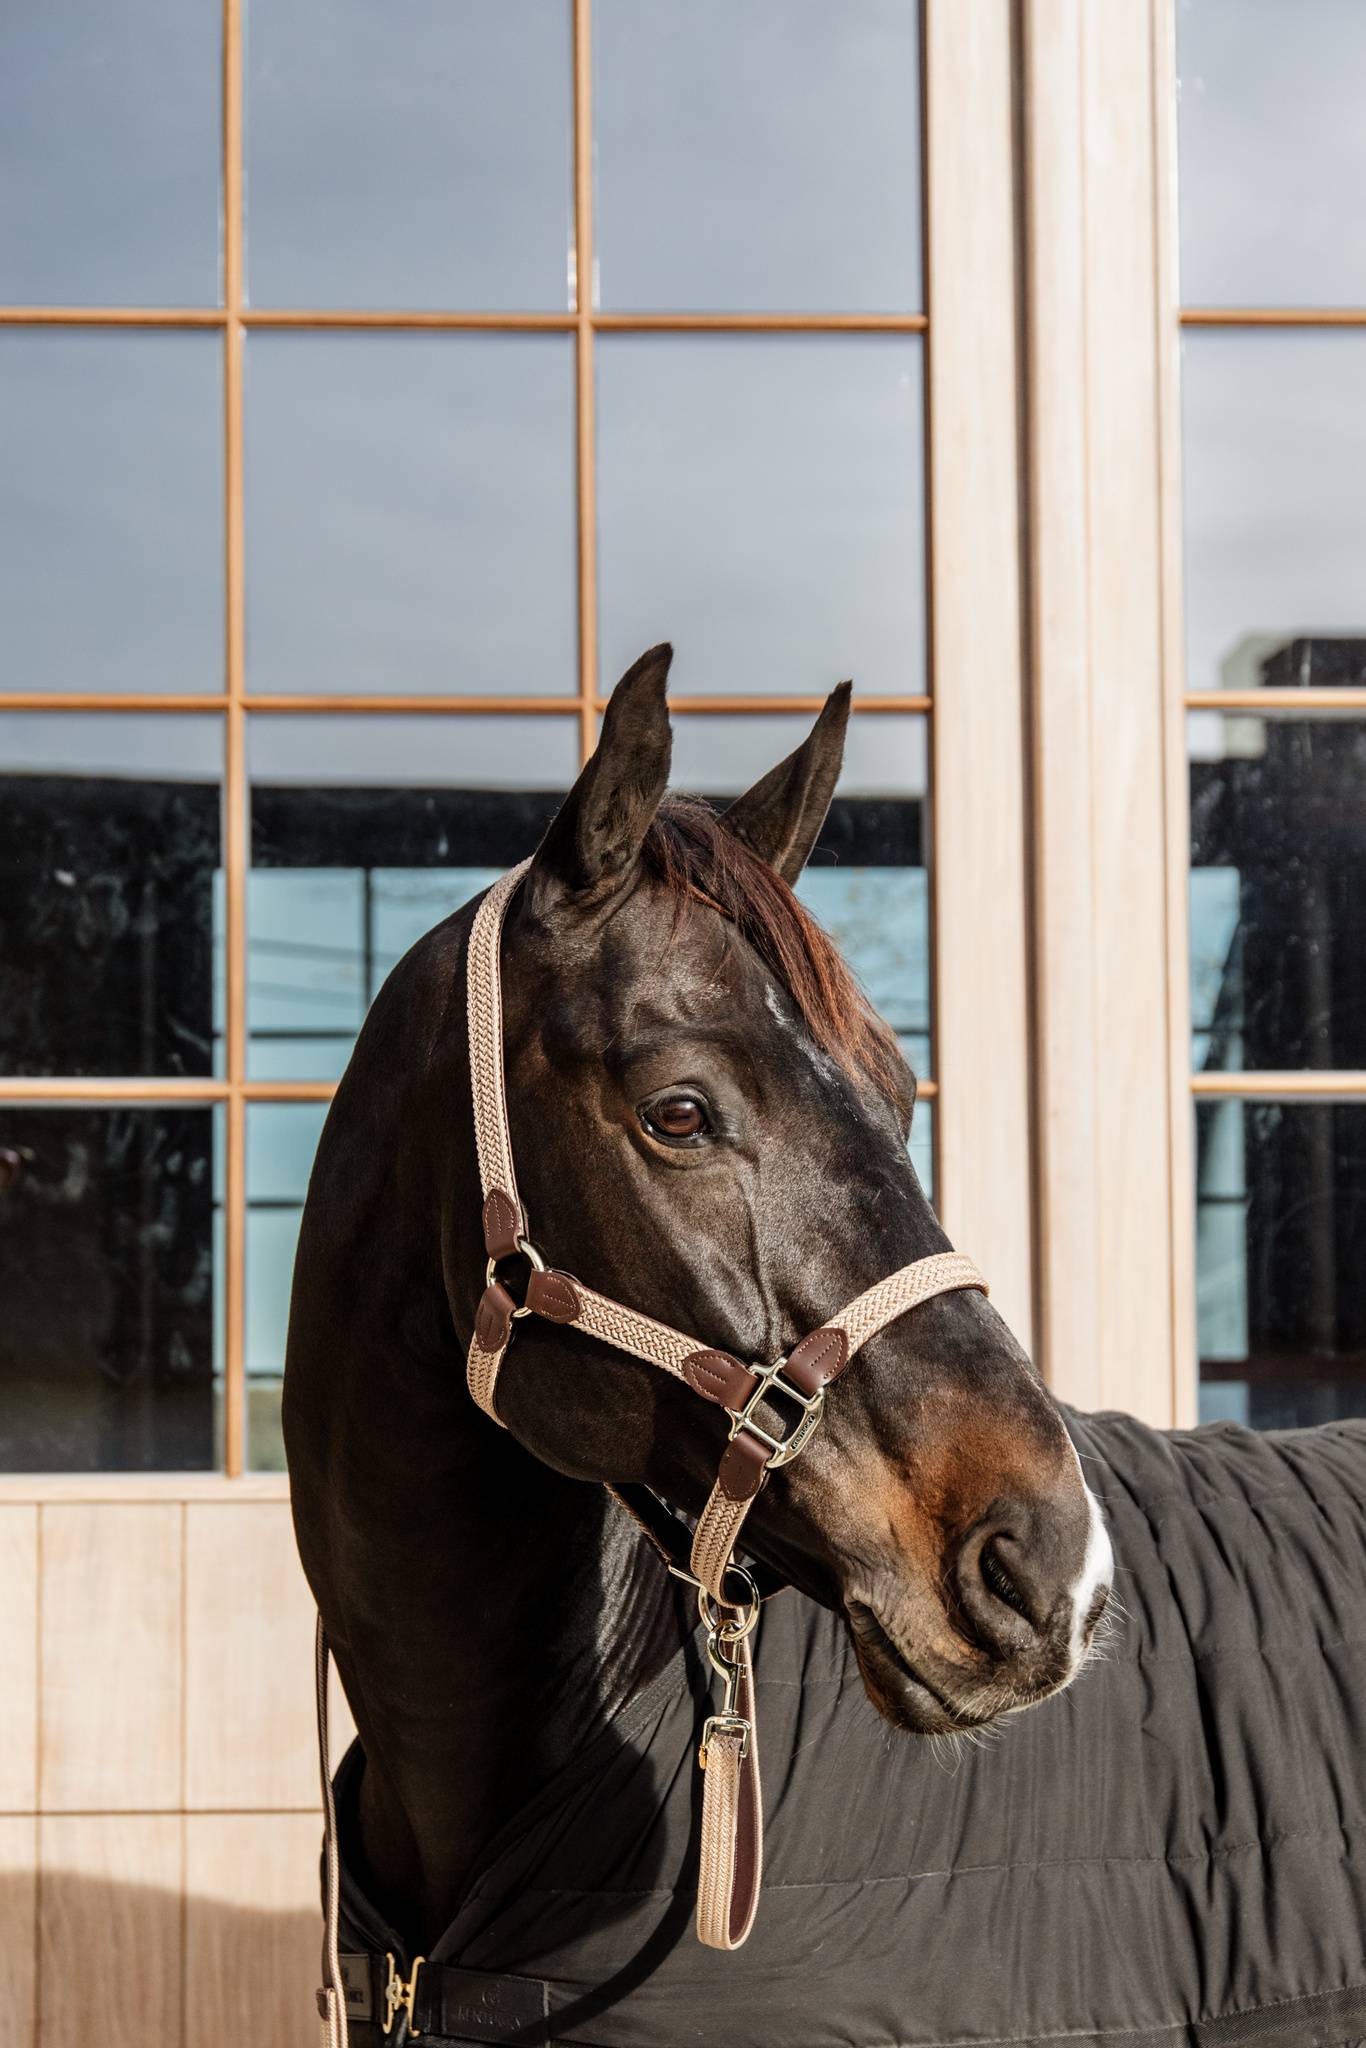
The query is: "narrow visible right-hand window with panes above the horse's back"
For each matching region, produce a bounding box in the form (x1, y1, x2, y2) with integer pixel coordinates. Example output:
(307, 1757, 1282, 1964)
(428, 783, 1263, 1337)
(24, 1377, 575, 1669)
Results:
(1178, 0, 1366, 1425)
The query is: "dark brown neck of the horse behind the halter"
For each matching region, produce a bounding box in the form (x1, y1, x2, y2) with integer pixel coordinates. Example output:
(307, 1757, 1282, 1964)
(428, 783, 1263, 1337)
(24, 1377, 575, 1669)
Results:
(294, 918, 682, 1946)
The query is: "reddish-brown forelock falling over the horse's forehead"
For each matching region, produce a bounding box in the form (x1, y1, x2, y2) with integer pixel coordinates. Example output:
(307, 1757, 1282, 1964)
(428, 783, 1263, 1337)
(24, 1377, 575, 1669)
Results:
(641, 795, 913, 1114)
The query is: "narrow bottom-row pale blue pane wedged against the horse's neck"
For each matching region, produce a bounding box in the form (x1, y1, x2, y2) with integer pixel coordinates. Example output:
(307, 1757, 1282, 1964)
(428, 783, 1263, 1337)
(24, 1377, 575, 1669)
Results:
(246, 1102, 328, 1473)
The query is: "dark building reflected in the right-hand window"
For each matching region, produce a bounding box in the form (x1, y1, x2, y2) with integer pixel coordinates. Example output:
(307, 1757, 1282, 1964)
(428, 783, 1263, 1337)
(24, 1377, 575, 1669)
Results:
(1190, 637, 1366, 1427)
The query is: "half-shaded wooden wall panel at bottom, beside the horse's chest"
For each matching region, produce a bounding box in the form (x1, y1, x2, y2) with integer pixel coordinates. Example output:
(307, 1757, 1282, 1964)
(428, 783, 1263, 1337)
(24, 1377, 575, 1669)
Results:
(184, 1812, 322, 2048)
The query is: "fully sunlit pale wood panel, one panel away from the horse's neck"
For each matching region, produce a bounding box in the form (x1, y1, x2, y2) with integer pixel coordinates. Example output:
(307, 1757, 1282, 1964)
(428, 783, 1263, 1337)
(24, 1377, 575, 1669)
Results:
(39, 1505, 182, 1812)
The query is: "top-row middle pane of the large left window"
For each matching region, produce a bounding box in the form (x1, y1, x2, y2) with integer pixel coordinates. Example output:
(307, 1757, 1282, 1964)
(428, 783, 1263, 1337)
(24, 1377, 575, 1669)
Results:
(246, 0, 573, 311)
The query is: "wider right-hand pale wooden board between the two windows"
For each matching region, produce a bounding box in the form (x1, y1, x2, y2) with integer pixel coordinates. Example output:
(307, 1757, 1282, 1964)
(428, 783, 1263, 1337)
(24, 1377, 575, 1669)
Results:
(1024, 0, 1184, 1423)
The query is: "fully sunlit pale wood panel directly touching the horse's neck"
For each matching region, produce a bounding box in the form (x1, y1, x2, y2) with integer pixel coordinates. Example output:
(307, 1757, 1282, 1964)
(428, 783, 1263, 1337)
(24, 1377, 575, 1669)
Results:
(184, 1501, 354, 1812)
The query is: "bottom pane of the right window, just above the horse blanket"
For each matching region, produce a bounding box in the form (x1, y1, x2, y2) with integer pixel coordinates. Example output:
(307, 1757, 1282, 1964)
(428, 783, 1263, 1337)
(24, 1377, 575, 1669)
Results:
(1196, 1102, 1366, 1430)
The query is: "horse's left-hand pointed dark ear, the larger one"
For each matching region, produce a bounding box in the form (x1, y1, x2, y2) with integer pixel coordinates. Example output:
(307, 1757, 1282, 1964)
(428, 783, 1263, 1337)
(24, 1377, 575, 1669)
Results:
(528, 641, 674, 897)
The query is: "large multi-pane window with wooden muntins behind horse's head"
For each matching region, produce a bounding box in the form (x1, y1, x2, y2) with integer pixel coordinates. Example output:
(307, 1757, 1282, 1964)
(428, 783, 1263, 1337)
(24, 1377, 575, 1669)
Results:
(0, 0, 942, 1475)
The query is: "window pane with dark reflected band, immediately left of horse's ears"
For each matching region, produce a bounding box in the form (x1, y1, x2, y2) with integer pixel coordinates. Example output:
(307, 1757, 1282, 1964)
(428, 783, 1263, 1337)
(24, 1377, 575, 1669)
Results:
(248, 715, 578, 1079)
